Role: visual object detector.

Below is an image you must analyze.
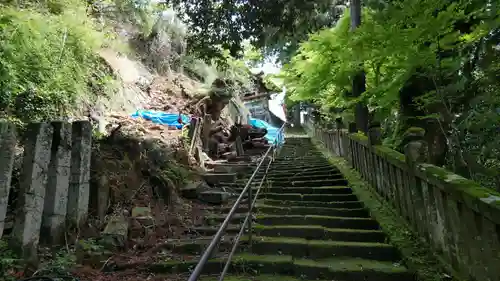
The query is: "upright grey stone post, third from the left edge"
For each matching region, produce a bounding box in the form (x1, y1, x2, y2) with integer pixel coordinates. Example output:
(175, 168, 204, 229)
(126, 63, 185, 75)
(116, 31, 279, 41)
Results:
(41, 122, 72, 244)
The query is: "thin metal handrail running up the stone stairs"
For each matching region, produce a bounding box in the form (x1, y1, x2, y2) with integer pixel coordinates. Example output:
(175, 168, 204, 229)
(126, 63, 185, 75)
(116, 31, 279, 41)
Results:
(188, 124, 285, 281)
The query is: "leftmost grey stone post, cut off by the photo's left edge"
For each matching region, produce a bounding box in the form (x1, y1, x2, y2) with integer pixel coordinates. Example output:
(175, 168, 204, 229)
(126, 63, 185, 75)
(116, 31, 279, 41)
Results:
(0, 122, 16, 238)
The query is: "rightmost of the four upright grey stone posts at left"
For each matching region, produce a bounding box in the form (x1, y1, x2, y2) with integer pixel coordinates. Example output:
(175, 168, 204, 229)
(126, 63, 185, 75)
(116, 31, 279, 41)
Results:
(66, 121, 92, 227)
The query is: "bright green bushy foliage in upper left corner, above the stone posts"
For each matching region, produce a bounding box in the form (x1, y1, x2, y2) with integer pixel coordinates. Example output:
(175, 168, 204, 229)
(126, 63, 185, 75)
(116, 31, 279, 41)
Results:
(0, 1, 114, 121)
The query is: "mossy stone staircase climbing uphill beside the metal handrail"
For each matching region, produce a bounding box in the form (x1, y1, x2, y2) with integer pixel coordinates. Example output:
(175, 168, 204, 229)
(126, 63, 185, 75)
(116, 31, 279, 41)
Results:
(128, 137, 416, 281)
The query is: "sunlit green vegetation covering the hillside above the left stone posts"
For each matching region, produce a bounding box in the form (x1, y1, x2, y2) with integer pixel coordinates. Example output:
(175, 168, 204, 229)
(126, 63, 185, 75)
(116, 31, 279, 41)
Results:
(0, 0, 274, 122)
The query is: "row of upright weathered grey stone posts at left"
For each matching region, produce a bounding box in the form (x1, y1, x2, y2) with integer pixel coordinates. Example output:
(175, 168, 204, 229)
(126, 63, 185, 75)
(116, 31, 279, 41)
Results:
(0, 121, 92, 255)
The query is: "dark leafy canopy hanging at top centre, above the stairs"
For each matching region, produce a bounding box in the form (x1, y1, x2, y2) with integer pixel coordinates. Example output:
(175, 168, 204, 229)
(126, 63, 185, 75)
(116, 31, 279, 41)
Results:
(166, 0, 347, 61)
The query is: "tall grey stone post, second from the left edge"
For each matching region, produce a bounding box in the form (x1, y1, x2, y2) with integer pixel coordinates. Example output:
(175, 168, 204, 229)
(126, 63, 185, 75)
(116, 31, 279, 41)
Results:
(11, 123, 54, 257)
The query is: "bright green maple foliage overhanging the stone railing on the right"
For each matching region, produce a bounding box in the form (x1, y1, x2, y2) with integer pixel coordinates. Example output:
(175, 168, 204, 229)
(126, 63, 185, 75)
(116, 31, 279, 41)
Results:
(282, 0, 500, 190)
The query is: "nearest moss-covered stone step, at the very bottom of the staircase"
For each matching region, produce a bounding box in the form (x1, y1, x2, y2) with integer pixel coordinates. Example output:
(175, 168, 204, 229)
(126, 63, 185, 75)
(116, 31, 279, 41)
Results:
(143, 254, 415, 281)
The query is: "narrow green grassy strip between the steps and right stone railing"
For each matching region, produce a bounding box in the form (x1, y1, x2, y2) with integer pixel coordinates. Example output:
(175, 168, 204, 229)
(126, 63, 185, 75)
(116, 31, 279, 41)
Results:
(313, 136, 463, 281)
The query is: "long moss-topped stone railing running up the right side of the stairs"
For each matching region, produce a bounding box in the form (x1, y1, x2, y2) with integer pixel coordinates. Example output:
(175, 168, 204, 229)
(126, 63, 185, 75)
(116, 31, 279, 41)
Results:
(306, 119, 500, 281)
